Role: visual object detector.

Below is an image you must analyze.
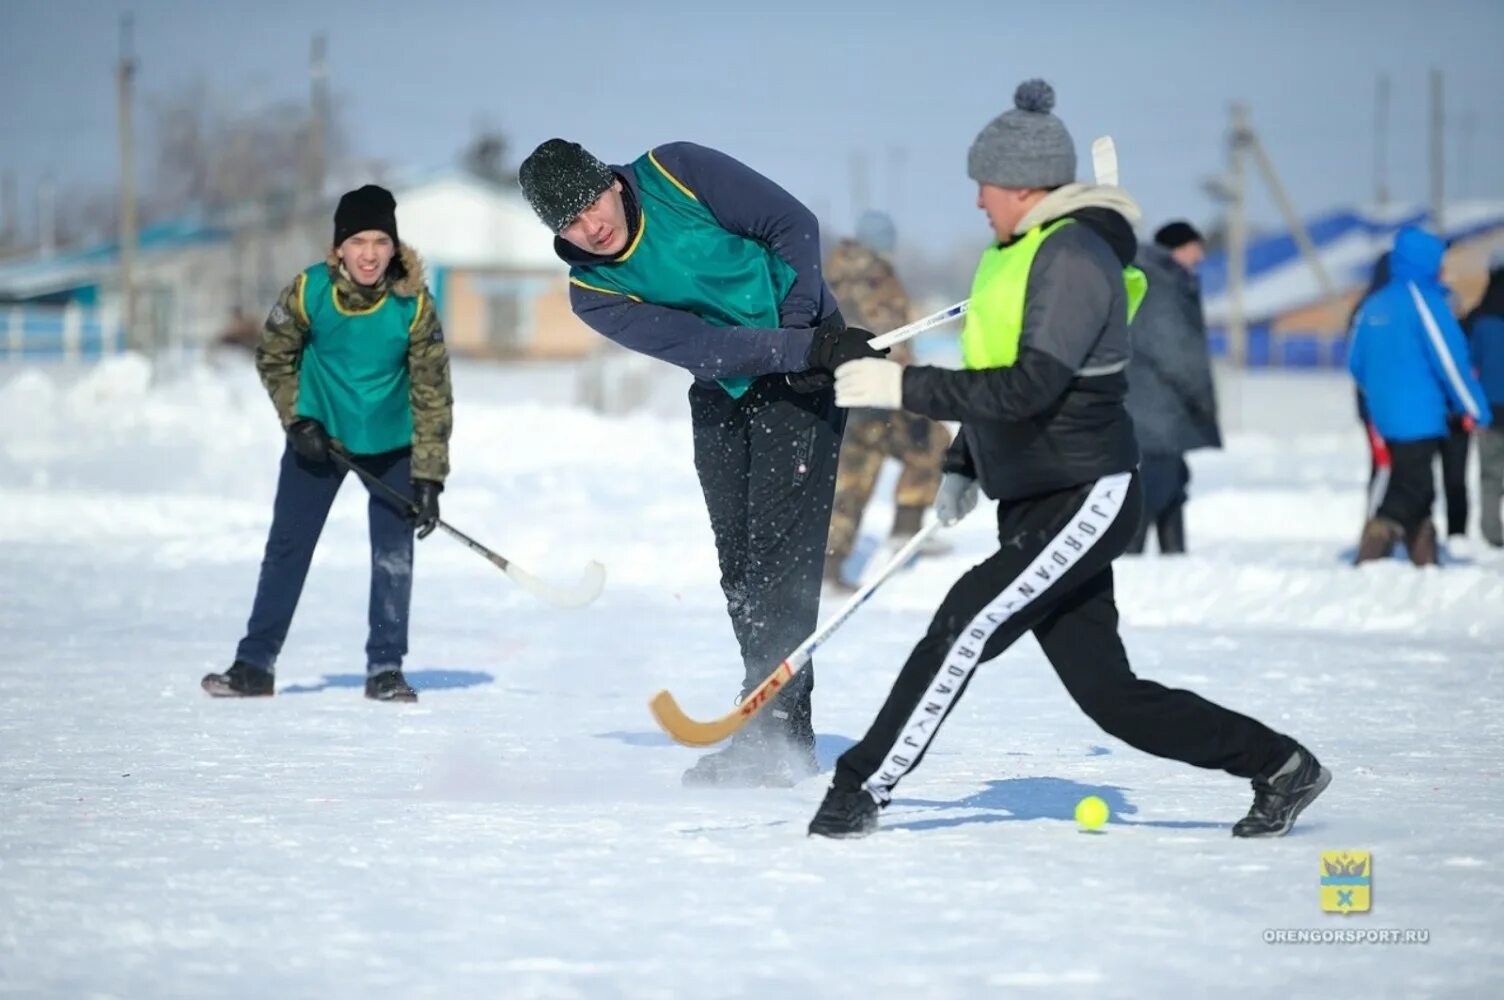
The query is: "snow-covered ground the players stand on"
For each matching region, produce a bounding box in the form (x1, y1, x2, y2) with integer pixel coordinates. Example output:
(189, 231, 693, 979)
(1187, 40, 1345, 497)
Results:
(0, 359, 1504, 1000)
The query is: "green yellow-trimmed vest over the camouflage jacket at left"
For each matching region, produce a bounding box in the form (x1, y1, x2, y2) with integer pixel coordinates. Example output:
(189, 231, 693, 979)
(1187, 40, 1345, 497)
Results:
(298, 263, 423, 454)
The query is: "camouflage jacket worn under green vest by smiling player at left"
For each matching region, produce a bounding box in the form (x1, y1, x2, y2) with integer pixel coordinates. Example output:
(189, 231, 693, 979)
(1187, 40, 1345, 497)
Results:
(256, 244, 454, 483)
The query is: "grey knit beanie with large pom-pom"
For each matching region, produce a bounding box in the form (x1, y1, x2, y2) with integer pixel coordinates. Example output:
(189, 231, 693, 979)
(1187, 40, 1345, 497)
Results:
(966, 80, 1075, 188)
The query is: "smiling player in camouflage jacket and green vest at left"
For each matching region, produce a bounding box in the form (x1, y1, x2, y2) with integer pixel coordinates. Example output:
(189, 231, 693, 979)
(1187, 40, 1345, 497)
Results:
(203, 185, 453, 701)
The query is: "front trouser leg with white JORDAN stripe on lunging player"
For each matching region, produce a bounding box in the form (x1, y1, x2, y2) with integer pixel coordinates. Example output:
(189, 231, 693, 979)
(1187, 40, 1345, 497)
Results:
(838, 472, 1142, 802)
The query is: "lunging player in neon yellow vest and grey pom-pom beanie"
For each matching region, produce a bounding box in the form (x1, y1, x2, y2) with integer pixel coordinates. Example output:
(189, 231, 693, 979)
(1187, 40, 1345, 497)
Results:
(809, 80, 1331, 838)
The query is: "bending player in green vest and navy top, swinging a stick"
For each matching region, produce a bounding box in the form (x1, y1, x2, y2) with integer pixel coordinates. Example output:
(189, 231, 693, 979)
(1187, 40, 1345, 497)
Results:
(519, 138, 886, 786)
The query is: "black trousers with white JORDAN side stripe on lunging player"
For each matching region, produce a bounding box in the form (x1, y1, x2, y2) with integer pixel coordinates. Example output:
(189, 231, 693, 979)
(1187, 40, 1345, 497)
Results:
(836, 472, 1295, 802)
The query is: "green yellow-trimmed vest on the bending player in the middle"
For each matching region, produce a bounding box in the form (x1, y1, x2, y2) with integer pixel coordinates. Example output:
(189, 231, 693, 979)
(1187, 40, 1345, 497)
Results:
(570, 150, 799, 397)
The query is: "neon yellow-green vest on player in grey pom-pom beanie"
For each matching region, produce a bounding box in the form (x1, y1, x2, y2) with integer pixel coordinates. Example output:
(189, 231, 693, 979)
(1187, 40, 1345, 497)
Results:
(961, 218, 1149, 368)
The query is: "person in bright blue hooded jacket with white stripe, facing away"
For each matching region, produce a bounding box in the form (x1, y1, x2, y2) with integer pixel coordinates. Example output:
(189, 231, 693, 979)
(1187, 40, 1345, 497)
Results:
(1348, 226, 1492, 565)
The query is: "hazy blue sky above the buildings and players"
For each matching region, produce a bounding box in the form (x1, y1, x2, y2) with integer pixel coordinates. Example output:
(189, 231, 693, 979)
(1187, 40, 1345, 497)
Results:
(0, 0, 1504, 248)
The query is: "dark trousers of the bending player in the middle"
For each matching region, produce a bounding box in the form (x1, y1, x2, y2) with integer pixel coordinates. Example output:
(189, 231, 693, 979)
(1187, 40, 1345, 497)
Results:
(689, 374, 845, 719)
